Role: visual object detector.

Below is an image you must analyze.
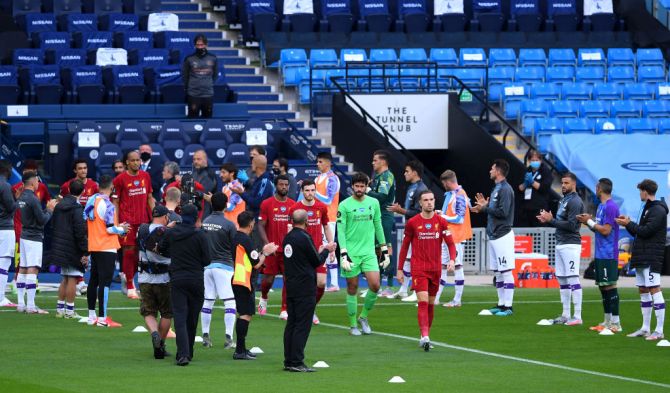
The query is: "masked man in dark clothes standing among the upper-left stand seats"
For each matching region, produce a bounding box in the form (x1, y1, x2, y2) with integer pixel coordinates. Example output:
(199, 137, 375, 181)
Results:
(181, 34, 219, 118)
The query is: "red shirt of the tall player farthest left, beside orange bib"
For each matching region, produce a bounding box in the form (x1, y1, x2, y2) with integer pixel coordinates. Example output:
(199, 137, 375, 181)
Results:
(112, 171, 153, 225)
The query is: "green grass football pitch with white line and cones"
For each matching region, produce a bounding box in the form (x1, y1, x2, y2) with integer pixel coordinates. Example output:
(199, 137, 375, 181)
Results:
(0, 286, 670, 393)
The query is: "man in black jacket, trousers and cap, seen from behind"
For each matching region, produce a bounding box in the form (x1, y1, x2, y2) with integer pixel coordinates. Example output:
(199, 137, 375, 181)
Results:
(158, 204, 212, 366)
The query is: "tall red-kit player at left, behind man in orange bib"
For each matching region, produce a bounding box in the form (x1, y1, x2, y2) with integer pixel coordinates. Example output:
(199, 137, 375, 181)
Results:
(113, 150, 154, 299)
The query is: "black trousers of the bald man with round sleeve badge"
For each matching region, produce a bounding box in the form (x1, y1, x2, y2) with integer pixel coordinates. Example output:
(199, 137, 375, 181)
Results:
(284, 296, 316, 367)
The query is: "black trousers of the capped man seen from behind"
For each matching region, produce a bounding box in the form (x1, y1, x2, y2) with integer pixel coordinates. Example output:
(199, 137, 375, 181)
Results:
(170, 279, 205, 359)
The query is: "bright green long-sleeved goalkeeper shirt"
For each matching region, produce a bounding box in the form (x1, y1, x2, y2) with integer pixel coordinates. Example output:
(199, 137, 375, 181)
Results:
(337, 196, 386, 256)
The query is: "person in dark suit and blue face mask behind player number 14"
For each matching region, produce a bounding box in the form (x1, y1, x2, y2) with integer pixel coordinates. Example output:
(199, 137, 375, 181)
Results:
(517, 150, 553, 227)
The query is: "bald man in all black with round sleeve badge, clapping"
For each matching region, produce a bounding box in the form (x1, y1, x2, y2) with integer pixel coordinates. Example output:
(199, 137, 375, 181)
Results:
(283, 209, 335, 372)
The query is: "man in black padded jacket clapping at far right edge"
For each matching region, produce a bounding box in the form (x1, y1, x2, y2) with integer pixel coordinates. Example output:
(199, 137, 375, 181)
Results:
(616, 179, 668, 341)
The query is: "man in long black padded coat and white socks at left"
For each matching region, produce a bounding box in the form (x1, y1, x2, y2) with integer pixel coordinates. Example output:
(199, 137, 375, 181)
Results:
(51, 180, 88, 320)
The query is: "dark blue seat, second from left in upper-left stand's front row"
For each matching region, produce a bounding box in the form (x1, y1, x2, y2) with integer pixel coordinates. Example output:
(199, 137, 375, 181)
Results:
(21, 65, 64, 105)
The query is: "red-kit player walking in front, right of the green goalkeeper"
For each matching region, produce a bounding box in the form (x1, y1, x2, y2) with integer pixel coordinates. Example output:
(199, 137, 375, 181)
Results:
(397, 190, 456, 352)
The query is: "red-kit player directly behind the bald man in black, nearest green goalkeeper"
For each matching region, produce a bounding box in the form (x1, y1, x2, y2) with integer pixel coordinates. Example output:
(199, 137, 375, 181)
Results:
(289, 179, 334, 325)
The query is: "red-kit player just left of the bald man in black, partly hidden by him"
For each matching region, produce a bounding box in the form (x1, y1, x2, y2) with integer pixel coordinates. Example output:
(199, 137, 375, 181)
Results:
(258, 175, 295, 320)
